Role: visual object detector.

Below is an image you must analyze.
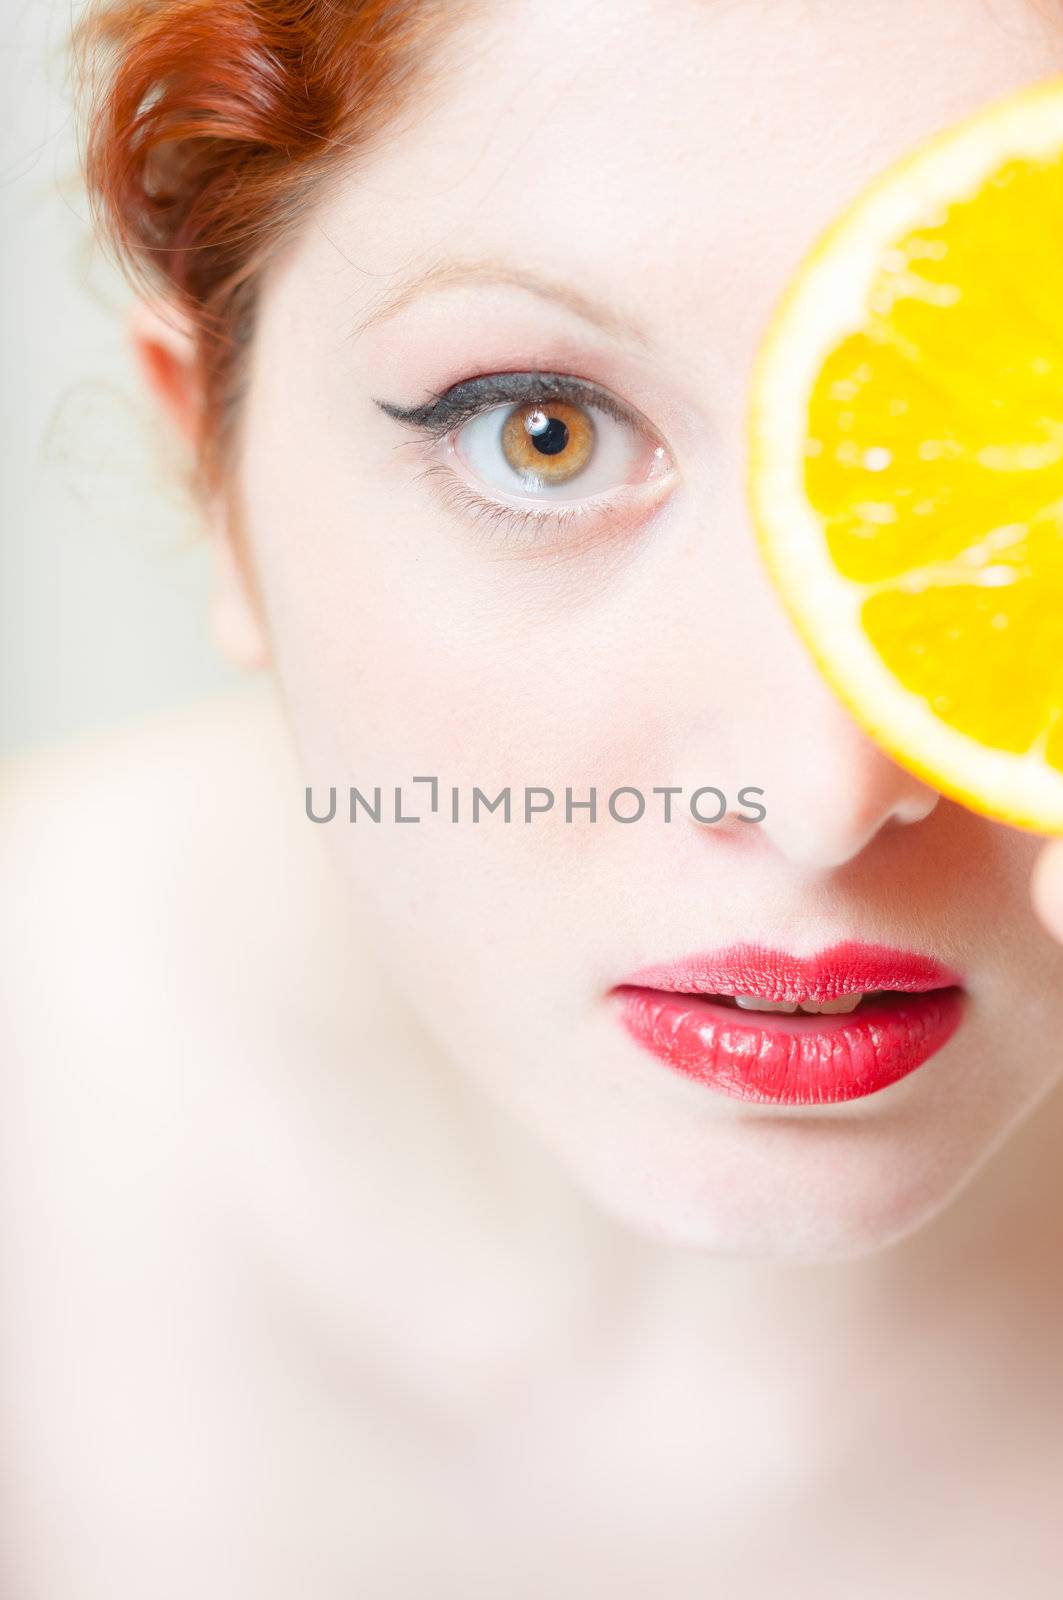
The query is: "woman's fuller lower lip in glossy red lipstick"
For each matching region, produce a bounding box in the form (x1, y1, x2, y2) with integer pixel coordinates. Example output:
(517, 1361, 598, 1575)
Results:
(613, 986, 964, 1106)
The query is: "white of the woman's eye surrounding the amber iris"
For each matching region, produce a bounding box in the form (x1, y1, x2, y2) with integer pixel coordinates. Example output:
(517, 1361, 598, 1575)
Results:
(453, 402, 650, 501)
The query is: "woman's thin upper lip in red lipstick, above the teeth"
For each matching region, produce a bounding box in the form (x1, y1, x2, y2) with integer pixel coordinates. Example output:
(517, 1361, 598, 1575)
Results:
(621, 942, 962, 1005)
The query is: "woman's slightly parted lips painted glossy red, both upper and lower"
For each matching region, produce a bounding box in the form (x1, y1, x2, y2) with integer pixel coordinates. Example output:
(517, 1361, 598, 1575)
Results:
(612, 944, 965, 1106)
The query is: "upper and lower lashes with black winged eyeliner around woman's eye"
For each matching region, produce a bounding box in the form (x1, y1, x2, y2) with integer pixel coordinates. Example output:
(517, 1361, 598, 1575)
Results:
(376, 371, 665, 534)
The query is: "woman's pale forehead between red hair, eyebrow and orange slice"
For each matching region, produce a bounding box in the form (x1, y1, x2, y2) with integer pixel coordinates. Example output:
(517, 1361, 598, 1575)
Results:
(272, 0, 1063, 356)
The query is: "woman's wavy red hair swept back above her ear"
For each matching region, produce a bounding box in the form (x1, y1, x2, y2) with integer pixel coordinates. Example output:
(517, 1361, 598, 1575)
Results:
(74, 0, 458, 486)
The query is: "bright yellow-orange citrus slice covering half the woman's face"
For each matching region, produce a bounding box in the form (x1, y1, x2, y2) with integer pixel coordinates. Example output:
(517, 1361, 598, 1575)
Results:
(749, 78, 1063, 834)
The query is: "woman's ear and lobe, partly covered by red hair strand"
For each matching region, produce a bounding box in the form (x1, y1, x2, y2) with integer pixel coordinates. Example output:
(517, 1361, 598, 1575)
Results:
(128, 299, 271, 670)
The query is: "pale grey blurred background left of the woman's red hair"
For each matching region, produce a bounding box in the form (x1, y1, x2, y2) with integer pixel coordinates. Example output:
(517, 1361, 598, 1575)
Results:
(0, 0, 235, 755)
